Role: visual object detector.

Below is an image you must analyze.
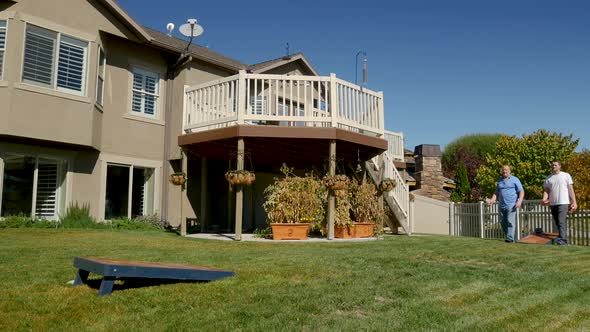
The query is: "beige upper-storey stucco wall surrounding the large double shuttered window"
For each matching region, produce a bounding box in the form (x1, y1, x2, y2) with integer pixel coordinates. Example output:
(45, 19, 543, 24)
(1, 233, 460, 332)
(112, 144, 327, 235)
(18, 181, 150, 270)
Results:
(0, 0, 149, 149)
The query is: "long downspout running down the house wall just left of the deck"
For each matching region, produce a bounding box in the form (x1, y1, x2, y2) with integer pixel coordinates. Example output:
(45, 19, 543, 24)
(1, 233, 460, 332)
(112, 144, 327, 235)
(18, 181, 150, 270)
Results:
(160, 54, 193, 221)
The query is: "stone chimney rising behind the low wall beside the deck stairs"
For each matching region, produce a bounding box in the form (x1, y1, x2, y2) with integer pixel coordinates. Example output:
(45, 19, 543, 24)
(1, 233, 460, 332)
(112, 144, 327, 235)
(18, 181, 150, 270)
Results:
(414, 144, 450, 201)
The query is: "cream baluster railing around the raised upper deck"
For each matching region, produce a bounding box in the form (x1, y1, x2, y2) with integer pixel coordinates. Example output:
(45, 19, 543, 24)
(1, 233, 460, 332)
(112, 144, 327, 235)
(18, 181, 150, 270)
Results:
(182, 71, 388, 137)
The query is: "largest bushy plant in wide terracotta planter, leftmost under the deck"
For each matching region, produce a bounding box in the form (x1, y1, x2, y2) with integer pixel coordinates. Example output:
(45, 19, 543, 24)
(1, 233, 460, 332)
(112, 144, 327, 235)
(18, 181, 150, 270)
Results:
(263, 164, 325, 240)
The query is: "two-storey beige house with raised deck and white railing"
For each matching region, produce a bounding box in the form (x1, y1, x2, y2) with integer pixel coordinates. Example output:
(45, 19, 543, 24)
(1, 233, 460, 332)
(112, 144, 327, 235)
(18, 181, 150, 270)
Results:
(0, 0, 408, 238)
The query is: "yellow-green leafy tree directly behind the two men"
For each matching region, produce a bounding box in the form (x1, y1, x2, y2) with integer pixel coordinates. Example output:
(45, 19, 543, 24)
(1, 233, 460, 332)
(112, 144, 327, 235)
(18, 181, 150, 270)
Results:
(475, 129, 579, 199)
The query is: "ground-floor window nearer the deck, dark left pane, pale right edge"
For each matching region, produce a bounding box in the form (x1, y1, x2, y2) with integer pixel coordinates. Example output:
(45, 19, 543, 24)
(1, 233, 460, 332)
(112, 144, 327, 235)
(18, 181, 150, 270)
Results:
(104, 164, 155, 220)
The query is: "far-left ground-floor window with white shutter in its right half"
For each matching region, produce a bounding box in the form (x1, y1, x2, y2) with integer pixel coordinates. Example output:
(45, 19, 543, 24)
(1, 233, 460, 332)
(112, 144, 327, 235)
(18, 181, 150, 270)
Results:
(0, 155, 66, 220)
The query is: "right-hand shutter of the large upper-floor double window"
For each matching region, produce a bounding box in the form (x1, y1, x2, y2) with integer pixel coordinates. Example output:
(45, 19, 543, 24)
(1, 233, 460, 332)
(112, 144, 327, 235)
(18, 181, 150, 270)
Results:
(57, 36, 87, 92)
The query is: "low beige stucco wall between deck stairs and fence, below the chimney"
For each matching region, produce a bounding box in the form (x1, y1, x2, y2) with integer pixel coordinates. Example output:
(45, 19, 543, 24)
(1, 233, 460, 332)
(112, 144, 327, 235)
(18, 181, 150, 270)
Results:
(412, 195, 449, 235)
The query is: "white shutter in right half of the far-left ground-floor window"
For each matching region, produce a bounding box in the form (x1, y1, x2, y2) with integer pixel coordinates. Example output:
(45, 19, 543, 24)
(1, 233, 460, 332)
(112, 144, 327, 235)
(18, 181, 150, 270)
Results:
(35, 159, 59, 219)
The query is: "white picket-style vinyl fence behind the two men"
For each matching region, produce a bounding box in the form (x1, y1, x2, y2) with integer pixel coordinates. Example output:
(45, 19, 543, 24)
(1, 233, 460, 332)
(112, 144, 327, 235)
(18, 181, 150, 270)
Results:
(449, 200, 590, 246)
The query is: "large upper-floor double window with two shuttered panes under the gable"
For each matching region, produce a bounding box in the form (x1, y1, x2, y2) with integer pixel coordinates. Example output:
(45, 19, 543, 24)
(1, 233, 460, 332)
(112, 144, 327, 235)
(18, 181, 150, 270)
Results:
(22, 24, 88, 95)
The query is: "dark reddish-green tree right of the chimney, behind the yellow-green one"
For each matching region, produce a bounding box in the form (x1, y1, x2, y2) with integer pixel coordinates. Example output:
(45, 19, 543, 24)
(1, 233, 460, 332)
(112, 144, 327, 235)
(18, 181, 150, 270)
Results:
(441, 134, 501, 200)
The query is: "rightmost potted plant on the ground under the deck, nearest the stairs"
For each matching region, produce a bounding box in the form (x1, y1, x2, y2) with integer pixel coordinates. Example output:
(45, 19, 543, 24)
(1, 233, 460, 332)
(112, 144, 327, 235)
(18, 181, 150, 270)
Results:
(350, 181, 383, 237)
